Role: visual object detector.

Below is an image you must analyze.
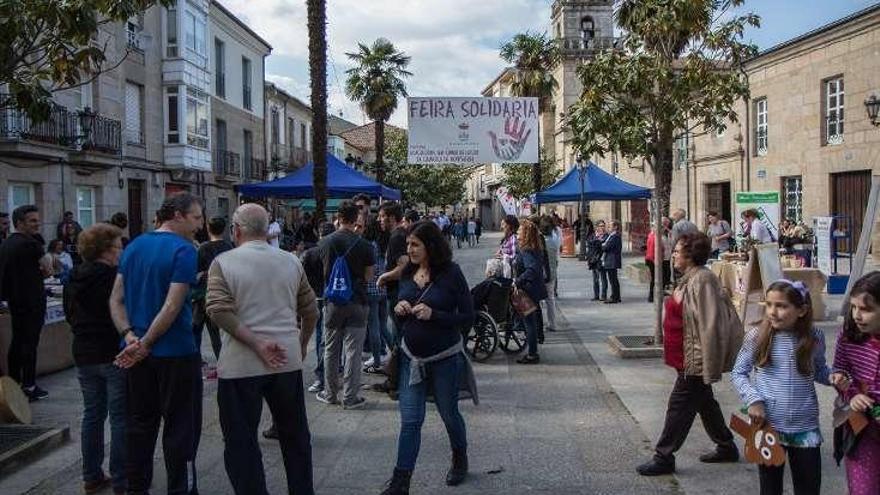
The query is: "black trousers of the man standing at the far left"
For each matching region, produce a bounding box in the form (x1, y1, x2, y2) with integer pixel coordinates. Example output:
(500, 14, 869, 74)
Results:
(7, 306, 46, 387)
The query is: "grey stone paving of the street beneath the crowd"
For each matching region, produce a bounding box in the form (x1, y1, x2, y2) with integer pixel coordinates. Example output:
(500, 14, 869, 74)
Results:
(0, 234, 680, 495)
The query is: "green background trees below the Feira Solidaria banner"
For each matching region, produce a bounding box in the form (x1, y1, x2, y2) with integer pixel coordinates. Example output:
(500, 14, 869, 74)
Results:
(385, 131, 475, 208)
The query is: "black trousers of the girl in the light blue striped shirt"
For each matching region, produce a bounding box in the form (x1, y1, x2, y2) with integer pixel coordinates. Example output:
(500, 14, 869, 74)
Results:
(758, 447, 822, 495)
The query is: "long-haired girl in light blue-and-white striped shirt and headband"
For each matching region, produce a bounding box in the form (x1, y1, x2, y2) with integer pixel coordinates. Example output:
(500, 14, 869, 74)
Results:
(731, 280, 831, 495)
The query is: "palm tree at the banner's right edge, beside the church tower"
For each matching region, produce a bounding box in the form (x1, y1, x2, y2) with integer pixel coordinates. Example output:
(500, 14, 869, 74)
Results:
(501, 31, 560, 196)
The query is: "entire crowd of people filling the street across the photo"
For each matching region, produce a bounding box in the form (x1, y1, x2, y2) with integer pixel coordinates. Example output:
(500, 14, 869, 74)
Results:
(0, 199, 880, 495)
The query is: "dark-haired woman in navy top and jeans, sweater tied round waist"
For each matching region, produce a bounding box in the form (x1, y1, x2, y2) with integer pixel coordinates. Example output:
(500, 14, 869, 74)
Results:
(382, 221, 477, 495)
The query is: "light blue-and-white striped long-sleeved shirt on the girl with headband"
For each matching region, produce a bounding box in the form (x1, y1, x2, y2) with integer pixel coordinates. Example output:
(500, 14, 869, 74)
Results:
(730, 328, 831, 433)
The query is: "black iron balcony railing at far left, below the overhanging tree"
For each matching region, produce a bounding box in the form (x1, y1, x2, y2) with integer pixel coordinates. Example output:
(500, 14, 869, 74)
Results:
(0, 98, 122, 166)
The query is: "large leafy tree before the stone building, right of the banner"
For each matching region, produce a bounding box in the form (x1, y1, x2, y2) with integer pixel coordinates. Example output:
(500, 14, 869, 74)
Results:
(566, 0, 760, 214)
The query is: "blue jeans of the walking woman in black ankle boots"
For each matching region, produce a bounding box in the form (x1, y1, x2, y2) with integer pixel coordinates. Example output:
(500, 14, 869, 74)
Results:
(397, 353, 467, 471)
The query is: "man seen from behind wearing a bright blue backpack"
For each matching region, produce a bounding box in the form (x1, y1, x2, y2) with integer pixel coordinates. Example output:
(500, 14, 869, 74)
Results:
(316, 201, 376, 409)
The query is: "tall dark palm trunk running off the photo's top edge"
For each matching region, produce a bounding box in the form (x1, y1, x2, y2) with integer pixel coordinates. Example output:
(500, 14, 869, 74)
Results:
(307, 0, 327, 220)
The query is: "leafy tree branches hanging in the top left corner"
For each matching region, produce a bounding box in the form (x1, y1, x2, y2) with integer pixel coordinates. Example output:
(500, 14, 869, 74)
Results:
(0, 0, 173, 120)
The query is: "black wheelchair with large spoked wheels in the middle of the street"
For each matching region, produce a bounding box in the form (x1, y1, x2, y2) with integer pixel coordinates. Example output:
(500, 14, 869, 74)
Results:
(464, 280, 526, 362)
